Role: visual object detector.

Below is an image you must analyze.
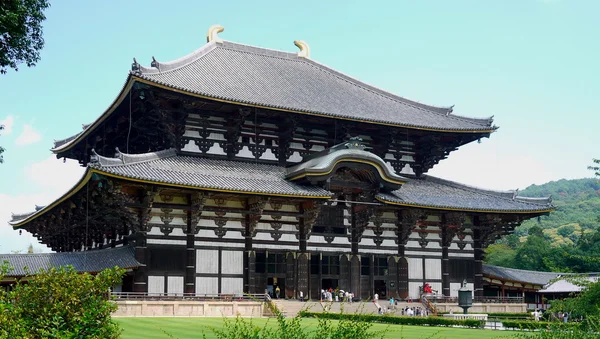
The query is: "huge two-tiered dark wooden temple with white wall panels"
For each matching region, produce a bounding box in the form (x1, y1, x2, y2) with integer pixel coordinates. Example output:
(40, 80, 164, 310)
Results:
(11, 26, 553, 298)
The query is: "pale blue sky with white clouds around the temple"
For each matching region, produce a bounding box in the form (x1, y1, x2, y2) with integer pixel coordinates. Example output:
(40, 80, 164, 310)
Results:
(0, 0, 600, 252)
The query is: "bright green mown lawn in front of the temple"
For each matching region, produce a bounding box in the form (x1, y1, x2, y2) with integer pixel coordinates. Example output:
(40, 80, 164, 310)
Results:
(115, 318, 513, 339)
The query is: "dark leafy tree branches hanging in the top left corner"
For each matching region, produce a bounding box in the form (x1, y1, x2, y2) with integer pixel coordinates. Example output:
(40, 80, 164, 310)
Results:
(0, 0, 50, 74)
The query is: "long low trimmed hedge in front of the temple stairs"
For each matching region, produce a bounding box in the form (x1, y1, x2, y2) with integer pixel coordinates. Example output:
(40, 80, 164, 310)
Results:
(300, 311, 485, 328)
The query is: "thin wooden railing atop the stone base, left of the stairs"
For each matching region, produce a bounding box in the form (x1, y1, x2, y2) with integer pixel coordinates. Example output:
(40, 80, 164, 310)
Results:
(111, 292, 265, 302)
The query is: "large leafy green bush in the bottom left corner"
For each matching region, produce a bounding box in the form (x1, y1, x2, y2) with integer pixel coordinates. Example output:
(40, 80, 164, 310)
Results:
(0, 265, 125, 339)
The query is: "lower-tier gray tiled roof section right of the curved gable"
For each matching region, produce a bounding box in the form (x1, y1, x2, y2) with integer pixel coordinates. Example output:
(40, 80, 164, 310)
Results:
(377, 175, 554, 212)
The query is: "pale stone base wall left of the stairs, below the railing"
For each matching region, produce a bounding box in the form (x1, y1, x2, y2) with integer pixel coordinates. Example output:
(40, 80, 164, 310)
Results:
(113, 300, 263, 317)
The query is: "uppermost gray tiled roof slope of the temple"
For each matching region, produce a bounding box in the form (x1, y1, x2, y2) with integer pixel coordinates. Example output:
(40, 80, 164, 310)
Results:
(135, 41, 493, 131)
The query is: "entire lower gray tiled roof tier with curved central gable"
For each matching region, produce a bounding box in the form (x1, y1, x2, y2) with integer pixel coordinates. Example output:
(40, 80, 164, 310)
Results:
(11, 150, 554, 227)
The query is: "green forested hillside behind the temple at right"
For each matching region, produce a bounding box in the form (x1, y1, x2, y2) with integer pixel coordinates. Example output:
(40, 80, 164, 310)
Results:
(486, 179, 600, 272)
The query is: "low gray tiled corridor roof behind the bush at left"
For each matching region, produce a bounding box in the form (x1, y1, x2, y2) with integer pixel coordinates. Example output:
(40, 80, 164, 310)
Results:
(0, 246, 140, 277)
